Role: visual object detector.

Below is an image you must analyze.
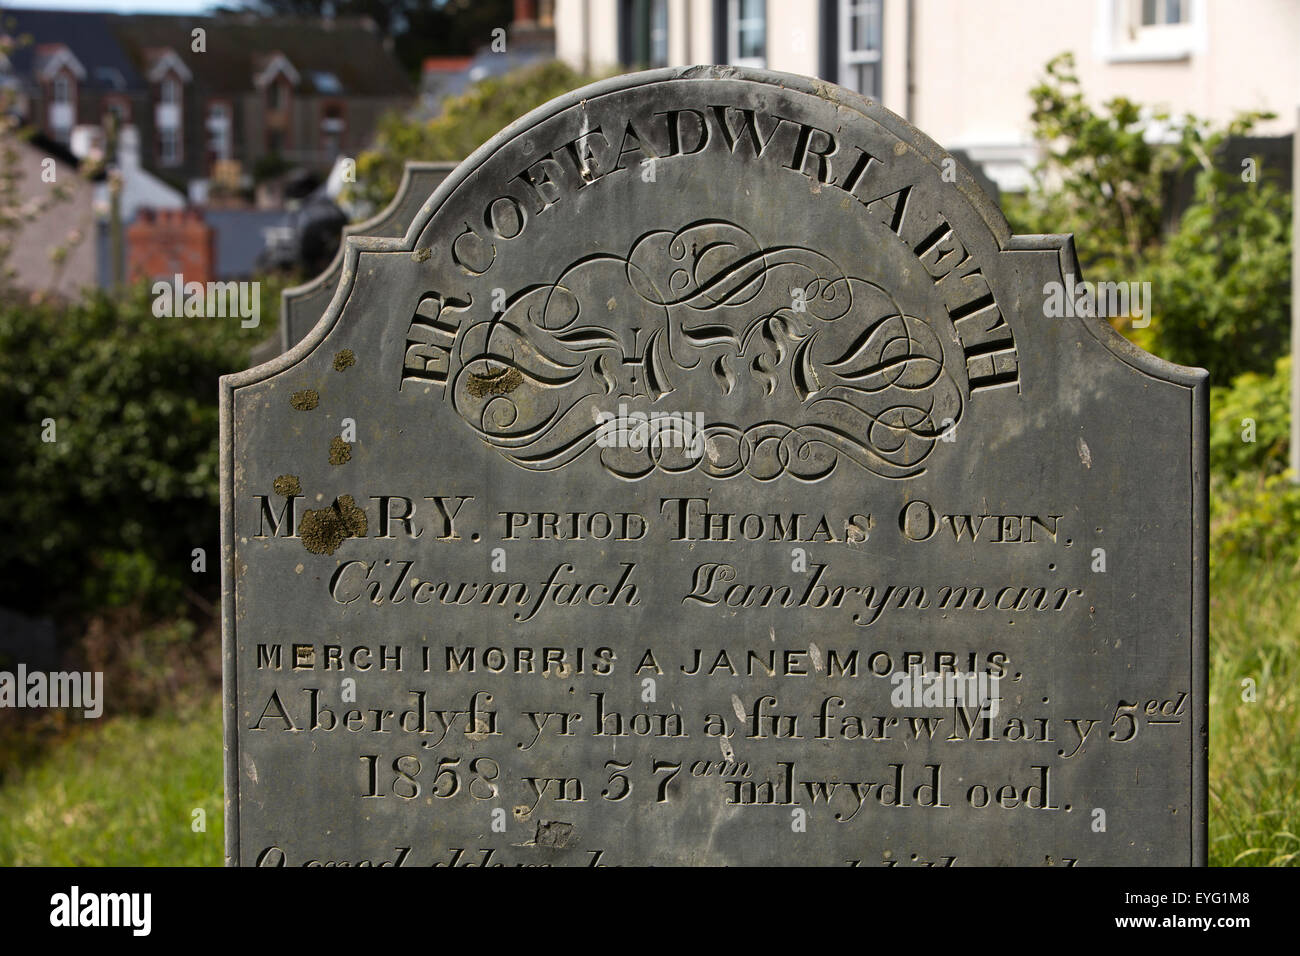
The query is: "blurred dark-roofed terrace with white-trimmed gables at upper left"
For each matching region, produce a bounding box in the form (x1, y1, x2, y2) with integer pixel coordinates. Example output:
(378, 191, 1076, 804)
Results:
(4, 9, 413, 199)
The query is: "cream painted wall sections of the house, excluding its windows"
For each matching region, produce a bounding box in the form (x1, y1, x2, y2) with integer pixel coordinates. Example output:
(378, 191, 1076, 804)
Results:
(555, 0, 1300, 189)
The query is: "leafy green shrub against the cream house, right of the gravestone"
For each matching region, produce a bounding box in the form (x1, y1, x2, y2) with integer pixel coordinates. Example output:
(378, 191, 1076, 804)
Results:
(1006, 53, 1291, 384)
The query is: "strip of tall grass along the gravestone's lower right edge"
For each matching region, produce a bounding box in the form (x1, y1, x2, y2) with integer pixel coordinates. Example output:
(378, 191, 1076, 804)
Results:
(1209, 559, 1300, 866)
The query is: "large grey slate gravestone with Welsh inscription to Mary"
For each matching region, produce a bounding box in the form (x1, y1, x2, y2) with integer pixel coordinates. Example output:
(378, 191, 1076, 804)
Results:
(222, 68, 1208, 866)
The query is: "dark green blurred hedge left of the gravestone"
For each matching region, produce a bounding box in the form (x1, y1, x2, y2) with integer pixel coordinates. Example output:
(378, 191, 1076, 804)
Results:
(0, 282, 280, 611)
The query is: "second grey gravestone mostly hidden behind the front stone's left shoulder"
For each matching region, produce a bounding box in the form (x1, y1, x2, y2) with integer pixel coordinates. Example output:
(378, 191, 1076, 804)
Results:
(278, 163, 456, 358)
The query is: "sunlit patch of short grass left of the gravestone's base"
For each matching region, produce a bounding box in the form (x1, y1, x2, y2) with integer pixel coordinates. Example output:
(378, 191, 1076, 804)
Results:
(0, 695, 224, 866)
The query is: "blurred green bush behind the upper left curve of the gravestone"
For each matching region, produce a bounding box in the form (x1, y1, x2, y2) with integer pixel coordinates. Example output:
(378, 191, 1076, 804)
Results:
(351, 60, 603, 209)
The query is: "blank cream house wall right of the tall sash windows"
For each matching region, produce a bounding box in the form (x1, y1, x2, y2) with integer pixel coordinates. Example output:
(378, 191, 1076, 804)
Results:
(909, 0, 1300, 178)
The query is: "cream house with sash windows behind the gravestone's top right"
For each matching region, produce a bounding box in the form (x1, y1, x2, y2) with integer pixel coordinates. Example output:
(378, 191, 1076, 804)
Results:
(554, 0, 1300, 191)
